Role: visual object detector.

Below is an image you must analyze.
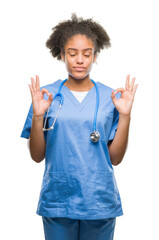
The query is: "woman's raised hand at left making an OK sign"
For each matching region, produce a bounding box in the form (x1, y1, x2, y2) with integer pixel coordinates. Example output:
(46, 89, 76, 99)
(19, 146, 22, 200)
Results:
(29, 75, 53, 117)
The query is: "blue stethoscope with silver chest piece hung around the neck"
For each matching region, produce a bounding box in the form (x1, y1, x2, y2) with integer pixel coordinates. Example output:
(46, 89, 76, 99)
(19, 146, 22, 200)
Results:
(43, 79, 100, 142)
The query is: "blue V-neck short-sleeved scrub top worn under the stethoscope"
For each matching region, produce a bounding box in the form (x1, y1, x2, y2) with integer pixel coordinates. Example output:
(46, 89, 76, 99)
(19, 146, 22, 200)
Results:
(21, 80, 123, 220)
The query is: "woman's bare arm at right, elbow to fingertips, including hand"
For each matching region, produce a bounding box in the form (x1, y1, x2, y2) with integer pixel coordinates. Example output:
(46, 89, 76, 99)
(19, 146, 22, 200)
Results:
(108, 75, 138, 165)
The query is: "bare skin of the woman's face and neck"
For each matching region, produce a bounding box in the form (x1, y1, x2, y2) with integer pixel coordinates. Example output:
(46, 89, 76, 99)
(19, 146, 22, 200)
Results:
(61, 34, 96, 91)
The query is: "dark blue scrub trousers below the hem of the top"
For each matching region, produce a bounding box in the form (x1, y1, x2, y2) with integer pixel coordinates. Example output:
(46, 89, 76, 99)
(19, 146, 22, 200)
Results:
(42, 217, 116, 240)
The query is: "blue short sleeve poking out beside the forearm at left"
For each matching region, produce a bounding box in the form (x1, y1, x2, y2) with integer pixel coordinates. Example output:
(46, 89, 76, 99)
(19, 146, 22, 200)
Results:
(20, 104, 33, 139)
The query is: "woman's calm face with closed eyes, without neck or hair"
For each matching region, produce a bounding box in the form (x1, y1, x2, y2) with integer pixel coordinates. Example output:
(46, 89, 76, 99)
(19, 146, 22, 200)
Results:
(61, 34, 96, 79)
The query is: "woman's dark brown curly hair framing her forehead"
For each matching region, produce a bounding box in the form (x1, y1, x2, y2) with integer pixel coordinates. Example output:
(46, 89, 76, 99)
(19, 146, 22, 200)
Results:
(46, 13, 111, 60)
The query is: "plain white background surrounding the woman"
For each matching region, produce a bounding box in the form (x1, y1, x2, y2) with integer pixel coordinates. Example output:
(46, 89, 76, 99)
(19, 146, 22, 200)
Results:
(0, 0, 159, 240)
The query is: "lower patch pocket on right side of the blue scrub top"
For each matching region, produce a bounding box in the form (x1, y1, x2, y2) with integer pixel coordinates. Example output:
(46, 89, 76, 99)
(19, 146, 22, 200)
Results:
(95, 171, 118, 208)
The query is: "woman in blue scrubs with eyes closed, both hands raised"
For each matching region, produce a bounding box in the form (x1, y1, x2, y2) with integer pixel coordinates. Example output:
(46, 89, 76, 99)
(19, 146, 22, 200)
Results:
(21, 14, 138, 240)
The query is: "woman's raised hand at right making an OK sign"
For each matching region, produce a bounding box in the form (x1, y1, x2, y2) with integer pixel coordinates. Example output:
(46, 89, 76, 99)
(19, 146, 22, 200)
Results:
(111, 75, 138, 116)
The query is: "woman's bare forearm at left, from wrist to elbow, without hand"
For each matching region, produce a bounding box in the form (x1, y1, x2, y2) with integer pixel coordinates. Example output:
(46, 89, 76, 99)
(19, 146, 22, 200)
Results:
(29, 117, 45, 163)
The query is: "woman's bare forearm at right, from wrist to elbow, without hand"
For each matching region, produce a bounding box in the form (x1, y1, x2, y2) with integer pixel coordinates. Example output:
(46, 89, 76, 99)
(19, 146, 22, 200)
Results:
(108, 115, 131, 165)
